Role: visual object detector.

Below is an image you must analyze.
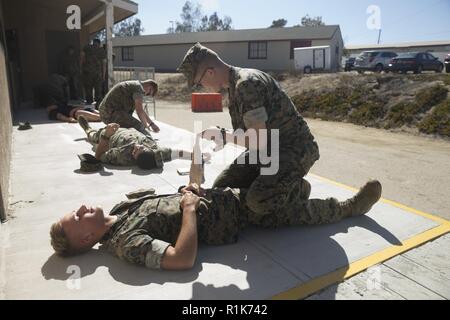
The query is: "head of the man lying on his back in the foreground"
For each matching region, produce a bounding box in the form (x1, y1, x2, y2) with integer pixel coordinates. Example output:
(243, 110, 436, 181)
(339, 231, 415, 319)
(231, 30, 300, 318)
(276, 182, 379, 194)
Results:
(50, 205, 108, 257)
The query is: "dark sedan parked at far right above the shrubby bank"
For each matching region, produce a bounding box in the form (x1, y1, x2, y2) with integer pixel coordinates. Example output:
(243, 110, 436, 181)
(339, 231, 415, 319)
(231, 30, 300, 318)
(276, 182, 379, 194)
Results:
(388, 52, 444, 74)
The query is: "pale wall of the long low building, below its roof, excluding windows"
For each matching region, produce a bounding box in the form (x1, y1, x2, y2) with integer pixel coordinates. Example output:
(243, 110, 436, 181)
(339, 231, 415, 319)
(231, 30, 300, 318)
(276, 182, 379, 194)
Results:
(114, 40, 342, 72)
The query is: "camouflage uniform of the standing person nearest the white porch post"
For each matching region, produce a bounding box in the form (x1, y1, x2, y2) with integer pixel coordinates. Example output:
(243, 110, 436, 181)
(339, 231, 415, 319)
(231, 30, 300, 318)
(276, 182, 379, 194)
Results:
(82, 45, 106, 104)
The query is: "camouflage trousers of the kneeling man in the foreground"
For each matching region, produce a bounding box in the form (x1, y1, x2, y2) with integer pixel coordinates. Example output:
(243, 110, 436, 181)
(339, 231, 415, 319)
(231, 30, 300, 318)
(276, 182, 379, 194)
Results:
(214, 142, 344, 228)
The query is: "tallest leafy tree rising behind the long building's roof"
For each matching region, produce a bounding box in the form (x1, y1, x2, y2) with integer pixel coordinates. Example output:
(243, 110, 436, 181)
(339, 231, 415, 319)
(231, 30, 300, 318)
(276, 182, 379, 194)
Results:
(171, 1, 232, 33)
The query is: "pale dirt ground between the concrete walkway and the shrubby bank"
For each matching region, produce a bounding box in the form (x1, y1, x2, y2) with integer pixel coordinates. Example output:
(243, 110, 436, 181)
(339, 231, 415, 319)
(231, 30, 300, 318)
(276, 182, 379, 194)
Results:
(157, 101, 450, 219)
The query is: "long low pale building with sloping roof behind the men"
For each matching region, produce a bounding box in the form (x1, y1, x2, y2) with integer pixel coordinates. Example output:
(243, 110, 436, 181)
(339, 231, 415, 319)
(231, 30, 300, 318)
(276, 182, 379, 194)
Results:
(113, 25, 344, 72)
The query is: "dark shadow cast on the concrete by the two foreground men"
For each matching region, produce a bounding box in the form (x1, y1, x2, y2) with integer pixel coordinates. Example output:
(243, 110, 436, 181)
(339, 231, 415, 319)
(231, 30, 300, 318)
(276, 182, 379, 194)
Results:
(41, 217, 401, 300)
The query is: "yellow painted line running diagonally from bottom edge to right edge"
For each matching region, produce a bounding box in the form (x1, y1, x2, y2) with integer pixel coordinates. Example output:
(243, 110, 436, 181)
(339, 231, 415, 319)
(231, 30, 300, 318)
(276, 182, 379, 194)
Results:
(272, 224, 450, 300)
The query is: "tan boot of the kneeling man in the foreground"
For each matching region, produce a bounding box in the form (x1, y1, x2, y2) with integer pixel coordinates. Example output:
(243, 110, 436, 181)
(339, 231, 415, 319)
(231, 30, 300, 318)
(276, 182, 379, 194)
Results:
(341, 180, 382, 217)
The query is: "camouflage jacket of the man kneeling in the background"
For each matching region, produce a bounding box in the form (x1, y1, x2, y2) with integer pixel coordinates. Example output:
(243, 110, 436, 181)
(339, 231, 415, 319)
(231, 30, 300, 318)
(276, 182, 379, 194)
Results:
(99, 81, 145, 114)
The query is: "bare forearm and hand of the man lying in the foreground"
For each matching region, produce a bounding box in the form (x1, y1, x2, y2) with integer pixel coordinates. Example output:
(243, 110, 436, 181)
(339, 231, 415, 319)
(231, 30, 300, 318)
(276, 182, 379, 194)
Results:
(161, 192, 200, 270)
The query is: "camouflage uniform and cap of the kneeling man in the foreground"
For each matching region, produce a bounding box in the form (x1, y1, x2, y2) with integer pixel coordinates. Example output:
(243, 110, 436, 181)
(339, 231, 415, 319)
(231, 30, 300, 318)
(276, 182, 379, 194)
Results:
(178, 44, 341, 224)
